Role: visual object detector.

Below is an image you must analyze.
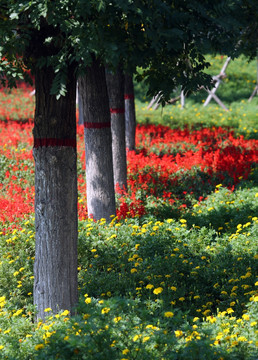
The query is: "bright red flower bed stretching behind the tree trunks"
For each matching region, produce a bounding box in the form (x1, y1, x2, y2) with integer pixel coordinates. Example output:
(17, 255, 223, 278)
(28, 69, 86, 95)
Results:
(0, 122, 258, 223)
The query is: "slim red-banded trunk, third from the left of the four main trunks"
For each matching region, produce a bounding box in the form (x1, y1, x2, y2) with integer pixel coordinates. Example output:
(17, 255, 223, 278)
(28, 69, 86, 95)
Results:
(106, 69, 127, 190)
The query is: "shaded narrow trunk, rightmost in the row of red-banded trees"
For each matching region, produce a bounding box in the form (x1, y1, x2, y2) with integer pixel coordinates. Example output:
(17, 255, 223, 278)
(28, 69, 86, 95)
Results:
(124, 74, 136, 150)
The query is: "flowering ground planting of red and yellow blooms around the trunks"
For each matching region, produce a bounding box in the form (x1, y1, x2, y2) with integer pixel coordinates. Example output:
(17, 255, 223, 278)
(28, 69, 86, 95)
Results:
(0, 56, 258, 360)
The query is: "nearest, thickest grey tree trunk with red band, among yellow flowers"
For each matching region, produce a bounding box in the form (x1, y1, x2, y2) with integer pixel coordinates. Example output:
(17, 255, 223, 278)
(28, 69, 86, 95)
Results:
(33, 67, 78, 320)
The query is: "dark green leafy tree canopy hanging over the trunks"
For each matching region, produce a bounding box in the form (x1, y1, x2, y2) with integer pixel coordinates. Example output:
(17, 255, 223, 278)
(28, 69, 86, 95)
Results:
(0, 0, 257, 97)
